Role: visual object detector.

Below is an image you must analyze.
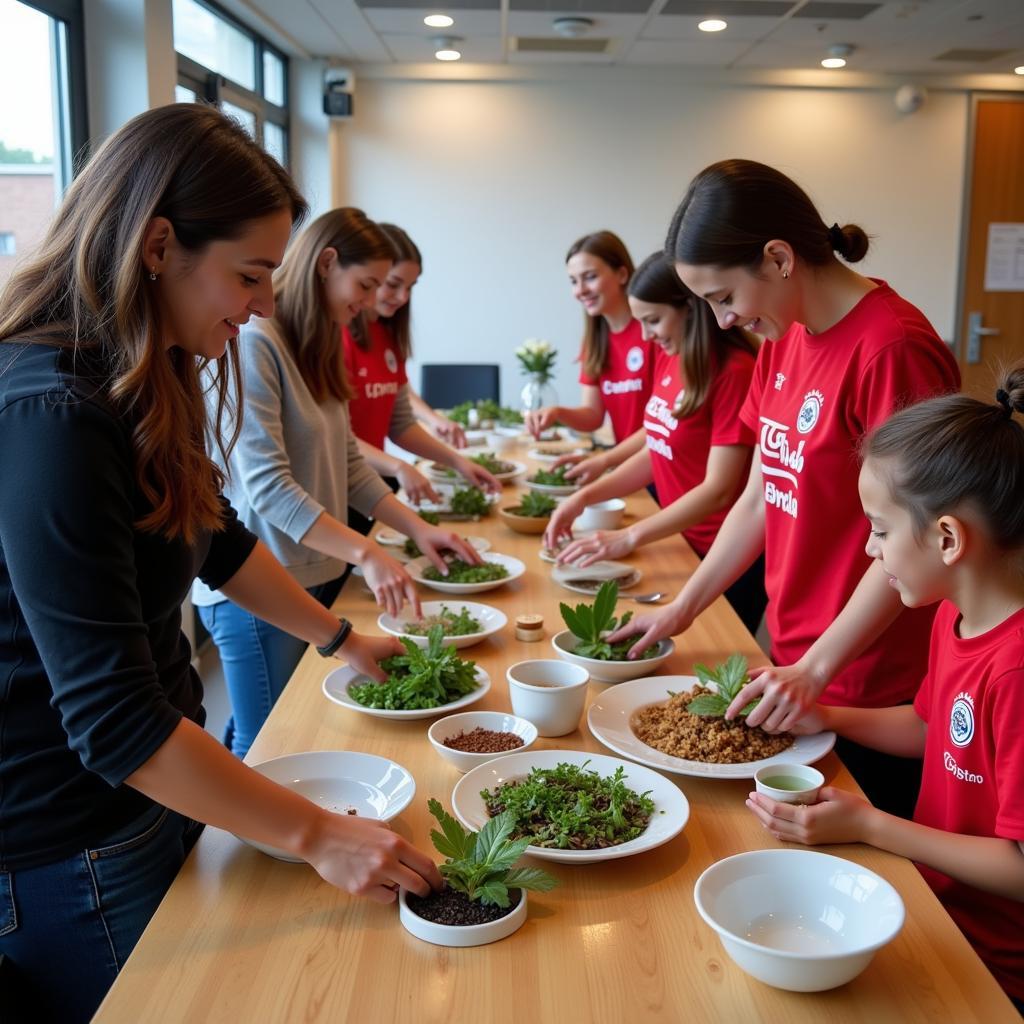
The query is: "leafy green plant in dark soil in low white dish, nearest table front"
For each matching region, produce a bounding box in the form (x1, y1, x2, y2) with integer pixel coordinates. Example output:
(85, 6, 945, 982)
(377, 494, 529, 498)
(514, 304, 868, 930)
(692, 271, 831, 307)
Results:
(398, 800, 558, 946)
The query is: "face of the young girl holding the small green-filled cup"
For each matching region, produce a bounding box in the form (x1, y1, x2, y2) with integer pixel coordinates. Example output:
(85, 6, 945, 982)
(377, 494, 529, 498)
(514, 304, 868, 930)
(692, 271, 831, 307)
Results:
(857, 459, 948, 608)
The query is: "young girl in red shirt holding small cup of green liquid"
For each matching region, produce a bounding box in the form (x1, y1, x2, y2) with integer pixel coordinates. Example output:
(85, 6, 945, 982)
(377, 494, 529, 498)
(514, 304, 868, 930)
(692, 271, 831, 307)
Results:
(748, 366, 1024, 1010)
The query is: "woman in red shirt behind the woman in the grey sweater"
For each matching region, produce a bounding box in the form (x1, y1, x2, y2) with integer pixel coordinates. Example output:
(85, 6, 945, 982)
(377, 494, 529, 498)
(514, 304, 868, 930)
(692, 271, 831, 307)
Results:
(342, 224, 501, 520)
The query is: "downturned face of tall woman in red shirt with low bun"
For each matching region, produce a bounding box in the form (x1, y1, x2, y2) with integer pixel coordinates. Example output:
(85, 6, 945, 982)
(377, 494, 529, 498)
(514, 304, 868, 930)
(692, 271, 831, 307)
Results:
(676, 255, 799, 338)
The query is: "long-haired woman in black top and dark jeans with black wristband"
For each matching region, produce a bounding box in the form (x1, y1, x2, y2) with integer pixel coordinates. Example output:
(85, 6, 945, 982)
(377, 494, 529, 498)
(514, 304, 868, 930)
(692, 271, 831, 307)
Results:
(0, 104, 440, 1021)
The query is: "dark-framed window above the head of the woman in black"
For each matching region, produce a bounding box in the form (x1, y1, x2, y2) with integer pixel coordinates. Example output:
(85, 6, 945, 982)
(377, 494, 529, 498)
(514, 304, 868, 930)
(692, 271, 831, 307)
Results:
(173, 0, 288, 167)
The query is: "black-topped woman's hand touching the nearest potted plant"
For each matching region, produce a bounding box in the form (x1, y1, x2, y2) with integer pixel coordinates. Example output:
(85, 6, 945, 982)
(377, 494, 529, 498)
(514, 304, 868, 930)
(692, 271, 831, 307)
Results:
(304, 806, 442, 903)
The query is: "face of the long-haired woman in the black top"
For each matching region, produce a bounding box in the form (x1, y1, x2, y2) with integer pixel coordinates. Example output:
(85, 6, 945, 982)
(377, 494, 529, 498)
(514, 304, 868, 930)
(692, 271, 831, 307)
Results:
(151, 210, 292, 359)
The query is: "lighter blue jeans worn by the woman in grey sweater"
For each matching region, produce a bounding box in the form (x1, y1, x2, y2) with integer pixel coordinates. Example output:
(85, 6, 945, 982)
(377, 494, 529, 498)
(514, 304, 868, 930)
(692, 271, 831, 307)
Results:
(199, 580, 340, 758)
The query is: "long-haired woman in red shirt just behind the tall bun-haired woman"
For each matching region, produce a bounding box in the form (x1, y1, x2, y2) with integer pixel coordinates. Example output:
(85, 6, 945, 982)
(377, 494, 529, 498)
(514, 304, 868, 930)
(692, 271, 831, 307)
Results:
(545, 252, 767, 633)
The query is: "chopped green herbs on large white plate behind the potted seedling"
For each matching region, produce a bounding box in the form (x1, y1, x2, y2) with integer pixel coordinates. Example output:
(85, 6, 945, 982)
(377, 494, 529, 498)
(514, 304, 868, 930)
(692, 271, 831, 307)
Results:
(480, 762, 654, 850)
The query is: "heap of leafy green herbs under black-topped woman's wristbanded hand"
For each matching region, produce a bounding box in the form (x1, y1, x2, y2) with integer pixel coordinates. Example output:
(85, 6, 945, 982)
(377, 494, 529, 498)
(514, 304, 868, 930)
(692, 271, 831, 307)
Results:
(348, 626, 479, 711)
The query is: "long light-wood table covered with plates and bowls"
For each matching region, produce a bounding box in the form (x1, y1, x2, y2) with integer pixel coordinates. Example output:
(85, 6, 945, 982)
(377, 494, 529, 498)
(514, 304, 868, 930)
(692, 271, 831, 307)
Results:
(95, 444, 1020, 1024)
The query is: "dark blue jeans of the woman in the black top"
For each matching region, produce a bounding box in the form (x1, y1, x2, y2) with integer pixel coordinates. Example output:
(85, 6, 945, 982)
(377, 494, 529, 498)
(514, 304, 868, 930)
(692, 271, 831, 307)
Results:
(0, 805, 203, 1024)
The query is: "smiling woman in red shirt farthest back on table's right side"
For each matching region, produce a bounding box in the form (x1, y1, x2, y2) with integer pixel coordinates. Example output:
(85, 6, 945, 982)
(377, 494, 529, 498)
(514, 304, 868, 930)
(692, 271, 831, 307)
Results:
(525, 231, 654, 483)
